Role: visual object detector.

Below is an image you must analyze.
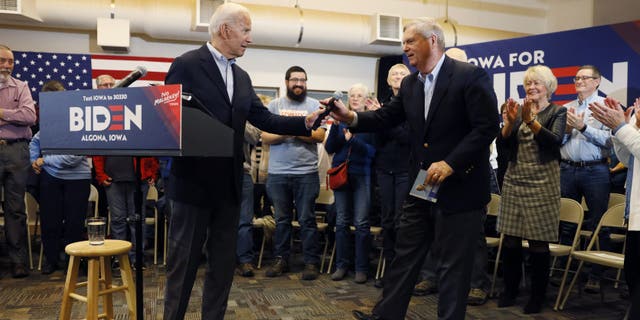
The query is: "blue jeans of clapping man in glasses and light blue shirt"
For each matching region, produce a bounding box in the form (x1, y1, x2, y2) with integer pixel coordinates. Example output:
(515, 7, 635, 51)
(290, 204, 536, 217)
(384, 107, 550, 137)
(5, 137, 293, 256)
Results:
(560, 162, 611, 277)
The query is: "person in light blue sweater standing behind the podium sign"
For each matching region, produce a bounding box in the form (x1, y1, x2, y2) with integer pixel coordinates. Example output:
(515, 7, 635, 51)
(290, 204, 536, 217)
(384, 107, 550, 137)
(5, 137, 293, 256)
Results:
(29, 81, 91, 274)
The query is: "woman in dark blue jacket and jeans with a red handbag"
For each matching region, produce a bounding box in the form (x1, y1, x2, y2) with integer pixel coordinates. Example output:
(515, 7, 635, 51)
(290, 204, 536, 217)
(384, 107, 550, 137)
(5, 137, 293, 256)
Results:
(325, 84, 375, 283)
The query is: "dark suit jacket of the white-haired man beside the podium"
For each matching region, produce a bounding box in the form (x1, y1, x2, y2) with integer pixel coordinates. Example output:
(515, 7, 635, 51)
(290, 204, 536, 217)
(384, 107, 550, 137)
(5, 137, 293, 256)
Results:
(165, 45, 310, 206)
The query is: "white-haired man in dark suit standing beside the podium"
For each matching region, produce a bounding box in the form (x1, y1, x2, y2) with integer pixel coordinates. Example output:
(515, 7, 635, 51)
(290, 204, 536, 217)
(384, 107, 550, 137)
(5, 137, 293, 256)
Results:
(164, 3, 319, 320)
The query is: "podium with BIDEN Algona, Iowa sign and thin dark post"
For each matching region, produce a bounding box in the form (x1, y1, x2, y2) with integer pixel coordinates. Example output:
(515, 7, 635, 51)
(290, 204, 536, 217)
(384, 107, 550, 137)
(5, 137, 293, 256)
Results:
(40, 85, 234, 319)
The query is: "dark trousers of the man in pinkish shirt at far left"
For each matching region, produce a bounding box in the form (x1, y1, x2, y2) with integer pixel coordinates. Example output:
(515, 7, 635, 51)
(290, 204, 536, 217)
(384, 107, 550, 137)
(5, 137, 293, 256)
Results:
(0, 142, 31, 264)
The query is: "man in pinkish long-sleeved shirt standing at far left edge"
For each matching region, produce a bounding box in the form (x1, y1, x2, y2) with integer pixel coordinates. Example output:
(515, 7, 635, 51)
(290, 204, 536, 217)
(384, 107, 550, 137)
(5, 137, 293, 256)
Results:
(0, 44, 36, 278)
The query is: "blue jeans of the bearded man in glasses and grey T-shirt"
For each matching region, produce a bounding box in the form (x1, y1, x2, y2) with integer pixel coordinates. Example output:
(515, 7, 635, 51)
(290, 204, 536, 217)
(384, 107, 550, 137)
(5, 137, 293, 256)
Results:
(267, 172, 320, 264)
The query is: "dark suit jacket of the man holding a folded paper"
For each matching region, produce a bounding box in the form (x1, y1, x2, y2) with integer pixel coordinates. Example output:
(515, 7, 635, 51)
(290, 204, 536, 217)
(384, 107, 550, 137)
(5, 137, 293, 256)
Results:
(356, 57, 499, 212)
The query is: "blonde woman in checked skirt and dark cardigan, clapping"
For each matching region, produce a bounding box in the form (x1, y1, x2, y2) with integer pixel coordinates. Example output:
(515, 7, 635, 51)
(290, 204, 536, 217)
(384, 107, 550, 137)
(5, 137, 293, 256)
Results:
(498, 65, 567, 314)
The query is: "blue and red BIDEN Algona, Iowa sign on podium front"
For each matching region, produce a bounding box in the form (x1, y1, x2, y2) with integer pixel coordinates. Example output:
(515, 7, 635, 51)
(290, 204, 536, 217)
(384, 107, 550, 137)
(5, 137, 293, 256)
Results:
(40, 85, 182, 155)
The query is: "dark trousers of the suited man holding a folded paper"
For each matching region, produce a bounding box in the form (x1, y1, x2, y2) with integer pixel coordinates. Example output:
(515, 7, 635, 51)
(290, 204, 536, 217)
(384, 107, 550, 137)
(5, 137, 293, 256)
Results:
(373, 199, 485, 320)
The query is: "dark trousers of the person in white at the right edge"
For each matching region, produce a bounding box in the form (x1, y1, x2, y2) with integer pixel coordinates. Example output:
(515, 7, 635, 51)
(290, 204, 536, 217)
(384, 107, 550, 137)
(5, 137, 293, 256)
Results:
(624, 230, 640, 319)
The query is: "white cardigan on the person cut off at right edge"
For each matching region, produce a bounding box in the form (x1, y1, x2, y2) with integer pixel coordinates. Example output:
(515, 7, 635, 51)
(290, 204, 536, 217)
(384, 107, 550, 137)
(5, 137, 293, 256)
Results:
(612, 115, 640, 231)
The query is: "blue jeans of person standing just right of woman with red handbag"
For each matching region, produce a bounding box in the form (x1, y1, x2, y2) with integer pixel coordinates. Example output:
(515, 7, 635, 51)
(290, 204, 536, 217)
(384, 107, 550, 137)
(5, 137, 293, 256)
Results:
(376, 169, 409, 263)
